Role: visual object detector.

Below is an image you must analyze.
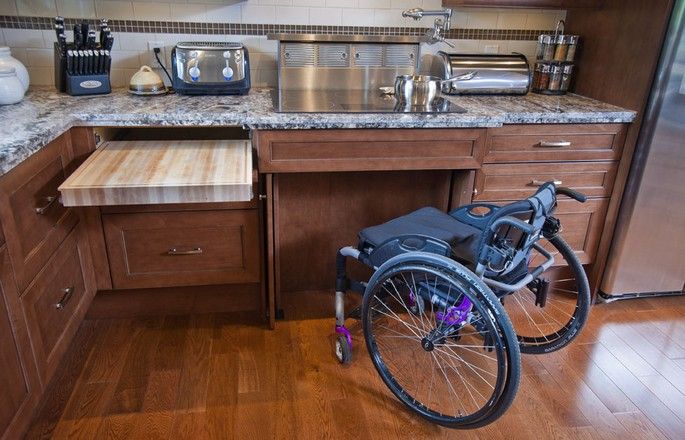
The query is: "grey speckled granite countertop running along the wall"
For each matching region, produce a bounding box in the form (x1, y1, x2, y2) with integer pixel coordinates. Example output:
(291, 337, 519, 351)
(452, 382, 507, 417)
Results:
(0, 88, 635, 175)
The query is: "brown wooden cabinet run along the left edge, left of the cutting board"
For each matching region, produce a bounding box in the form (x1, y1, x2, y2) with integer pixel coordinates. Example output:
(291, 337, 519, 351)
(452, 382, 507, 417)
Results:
(0, 128, 95, 439)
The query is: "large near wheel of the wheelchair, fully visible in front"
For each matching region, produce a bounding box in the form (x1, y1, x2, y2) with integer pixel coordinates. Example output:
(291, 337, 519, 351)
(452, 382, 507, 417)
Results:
(362, 252, 520, 429)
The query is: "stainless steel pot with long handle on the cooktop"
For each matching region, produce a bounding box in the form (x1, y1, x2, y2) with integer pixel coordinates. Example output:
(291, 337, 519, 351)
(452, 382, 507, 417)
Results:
(395, 72, 478, 106)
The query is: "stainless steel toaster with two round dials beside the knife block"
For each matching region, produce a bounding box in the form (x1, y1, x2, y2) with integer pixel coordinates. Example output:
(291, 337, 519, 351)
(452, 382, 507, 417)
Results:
(171, 42, 250, 95)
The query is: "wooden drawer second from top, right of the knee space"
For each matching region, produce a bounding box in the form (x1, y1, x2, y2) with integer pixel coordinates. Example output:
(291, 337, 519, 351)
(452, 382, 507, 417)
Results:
(473, 162, 618, 201)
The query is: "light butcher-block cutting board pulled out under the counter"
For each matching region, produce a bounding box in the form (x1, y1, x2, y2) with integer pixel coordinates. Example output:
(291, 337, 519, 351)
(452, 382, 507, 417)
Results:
(59, 140, 252, 206)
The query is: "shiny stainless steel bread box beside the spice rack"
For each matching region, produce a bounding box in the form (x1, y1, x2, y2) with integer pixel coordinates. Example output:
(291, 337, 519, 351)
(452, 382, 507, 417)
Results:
(432, 51, 531, 95)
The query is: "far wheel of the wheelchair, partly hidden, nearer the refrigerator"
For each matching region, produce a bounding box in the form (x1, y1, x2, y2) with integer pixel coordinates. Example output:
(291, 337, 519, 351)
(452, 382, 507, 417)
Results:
(502, 236, 590, 354)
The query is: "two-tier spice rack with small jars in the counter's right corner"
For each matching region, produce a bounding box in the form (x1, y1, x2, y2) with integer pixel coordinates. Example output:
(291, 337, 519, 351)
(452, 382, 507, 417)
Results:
(532, 20, 580, 95)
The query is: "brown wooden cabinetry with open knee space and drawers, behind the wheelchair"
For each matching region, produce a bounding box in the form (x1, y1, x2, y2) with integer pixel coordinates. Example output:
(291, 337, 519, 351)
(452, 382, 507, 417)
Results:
(260, 124, 626, 316)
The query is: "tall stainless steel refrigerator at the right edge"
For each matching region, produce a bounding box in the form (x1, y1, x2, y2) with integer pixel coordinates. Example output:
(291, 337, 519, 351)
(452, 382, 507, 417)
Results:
(600, 0, 685, 301)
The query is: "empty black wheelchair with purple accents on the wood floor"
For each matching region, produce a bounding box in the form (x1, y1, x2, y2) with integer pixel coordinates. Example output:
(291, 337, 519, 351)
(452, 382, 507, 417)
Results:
(335, 182, 590, 429)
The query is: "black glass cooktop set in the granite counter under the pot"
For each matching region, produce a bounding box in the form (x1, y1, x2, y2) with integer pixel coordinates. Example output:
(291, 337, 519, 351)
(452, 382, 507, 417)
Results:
(273, 90, 466, 114)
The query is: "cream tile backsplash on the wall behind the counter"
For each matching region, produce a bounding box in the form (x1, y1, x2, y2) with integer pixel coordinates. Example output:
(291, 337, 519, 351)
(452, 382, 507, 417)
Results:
(0, 0, 566, 87)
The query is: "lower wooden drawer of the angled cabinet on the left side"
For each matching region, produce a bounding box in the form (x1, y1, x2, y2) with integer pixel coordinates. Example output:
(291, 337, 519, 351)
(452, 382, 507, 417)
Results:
(21, 229, 94, 383)
